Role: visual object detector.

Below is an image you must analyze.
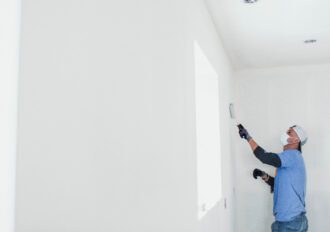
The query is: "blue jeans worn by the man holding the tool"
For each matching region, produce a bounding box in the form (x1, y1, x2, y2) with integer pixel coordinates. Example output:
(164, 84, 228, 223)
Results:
(272, 214, 308, 232)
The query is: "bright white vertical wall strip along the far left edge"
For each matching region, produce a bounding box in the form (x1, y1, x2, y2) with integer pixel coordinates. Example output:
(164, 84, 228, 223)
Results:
(0, 0, 20, 232)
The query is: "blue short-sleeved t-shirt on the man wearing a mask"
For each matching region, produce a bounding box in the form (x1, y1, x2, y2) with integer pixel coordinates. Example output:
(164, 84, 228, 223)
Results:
(273, 150, 306, 222)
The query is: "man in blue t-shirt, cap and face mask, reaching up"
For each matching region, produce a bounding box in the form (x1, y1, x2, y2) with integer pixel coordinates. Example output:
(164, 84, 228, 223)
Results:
(238, 124, 308, 232)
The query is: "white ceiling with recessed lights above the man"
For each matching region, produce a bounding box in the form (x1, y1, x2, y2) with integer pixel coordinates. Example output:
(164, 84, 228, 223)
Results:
(205, 0, 330, 70)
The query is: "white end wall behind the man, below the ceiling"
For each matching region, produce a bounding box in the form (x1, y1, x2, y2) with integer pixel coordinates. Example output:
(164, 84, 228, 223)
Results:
(234, 64, 330, 232)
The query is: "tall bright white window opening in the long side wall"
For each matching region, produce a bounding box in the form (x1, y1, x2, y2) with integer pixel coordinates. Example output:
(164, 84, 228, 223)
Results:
(194, 41, 222, 219)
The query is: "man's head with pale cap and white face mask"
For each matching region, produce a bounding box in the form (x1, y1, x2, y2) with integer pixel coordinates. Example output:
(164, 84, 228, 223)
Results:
(281, 125, 307, 151)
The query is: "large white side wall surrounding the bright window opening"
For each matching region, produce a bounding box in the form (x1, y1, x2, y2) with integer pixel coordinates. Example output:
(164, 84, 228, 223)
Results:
(16, 0, 233, 232)
